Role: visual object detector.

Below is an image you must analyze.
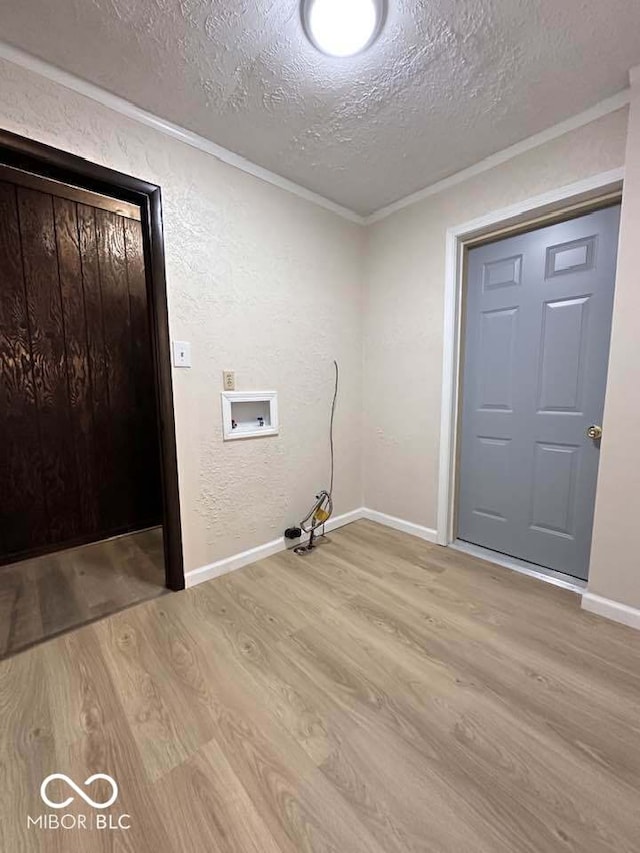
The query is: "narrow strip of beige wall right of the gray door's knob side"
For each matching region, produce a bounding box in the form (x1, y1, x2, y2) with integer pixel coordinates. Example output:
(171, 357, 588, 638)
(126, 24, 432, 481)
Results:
(589, 75, 640, 608)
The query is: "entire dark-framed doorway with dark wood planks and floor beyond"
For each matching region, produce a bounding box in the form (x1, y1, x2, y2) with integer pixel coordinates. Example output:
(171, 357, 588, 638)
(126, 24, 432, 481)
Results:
(0, 132, 184, 657)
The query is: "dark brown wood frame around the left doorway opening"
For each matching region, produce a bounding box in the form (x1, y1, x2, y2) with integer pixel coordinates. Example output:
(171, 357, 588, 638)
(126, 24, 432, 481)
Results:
(0, 130, 185, 590)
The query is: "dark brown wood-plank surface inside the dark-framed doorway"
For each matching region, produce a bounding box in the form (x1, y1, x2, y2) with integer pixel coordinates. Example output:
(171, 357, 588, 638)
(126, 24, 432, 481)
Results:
(0, 173, 162, 563)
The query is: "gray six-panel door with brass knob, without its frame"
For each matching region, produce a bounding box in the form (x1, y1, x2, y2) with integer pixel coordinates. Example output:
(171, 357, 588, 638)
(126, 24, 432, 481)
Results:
(458, 205, 620, 579)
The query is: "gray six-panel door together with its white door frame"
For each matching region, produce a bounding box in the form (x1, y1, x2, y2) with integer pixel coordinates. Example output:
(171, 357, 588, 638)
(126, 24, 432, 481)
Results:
(438, 173, 621, 588)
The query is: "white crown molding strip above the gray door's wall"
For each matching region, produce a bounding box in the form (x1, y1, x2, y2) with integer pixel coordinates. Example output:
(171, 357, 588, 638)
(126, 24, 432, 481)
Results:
(364, 88, 640, 225)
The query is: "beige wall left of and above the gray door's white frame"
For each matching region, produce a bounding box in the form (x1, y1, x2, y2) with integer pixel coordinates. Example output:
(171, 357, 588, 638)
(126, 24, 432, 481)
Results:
(363, 109, 637, 528)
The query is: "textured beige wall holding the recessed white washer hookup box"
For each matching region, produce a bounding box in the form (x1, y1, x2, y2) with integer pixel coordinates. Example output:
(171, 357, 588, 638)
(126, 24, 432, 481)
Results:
(0, 62, 364, 571)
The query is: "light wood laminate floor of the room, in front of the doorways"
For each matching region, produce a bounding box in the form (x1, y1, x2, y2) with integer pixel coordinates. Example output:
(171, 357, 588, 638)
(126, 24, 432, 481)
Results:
(0, 521, 640, 853)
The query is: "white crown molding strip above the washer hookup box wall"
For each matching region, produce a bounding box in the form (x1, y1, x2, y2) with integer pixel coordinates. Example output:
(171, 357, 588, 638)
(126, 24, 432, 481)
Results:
(0, 41, 364, 225)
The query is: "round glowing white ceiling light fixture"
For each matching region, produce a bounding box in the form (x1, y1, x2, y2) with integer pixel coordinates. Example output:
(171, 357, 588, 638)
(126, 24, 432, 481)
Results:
(301, 0, 387, 57)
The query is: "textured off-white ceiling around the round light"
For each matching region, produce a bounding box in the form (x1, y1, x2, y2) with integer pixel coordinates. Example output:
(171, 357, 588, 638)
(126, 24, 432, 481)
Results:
(0, 0, 640, 214)
